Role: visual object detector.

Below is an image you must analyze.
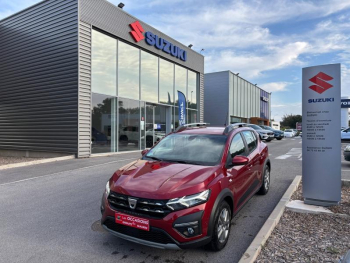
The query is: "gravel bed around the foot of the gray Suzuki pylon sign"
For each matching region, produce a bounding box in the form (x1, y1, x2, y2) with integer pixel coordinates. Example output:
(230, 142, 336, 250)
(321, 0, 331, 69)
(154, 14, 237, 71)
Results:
(256, 184, 350, 263)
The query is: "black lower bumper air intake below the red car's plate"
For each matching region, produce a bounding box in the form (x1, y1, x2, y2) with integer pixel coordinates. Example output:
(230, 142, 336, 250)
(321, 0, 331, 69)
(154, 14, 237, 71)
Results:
(103, 217, 175, 244)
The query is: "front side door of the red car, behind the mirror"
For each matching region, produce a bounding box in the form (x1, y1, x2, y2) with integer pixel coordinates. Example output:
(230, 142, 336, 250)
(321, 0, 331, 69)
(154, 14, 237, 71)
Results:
(226, 133, 252, 210)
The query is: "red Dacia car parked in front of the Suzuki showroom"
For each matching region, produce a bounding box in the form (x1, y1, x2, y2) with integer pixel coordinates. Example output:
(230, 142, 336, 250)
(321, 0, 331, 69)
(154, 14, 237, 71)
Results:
(101, 124, 271, 251)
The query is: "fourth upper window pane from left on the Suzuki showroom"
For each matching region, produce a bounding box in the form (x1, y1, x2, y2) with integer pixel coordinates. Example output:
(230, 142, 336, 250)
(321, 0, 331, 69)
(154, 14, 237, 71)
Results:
(159, 59, 174, 104)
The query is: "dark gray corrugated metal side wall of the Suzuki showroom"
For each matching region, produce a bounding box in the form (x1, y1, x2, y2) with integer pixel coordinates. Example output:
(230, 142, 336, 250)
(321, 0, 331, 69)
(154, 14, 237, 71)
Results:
(0, 0, 78, 156)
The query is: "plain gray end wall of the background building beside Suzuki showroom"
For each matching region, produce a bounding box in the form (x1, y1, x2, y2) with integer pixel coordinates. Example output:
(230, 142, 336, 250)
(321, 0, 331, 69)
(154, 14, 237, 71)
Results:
(204, 71, 229, 126)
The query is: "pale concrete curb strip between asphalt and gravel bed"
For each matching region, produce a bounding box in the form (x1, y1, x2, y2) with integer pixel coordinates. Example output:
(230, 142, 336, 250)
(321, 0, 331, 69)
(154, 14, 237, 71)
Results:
(239, 175, 301, 263)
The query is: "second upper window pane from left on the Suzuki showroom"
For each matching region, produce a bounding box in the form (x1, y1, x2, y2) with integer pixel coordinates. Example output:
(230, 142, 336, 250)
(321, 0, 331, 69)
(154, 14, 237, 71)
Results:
(118, 41, 140, 100)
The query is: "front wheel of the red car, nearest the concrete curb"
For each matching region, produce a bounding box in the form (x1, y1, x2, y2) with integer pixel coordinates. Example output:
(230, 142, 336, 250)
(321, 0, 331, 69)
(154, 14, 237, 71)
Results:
(209, 201, 232, 251)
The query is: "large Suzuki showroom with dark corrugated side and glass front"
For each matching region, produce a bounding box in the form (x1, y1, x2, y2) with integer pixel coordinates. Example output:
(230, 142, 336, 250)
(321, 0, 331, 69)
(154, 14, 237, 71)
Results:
(0, 0, 205, 157)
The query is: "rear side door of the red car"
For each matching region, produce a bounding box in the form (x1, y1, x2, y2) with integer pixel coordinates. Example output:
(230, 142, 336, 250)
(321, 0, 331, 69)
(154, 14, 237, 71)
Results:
(242, 131, 261, 192)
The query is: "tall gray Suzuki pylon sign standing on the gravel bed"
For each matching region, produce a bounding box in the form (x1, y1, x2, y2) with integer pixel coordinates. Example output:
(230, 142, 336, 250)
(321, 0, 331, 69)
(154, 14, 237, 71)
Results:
(302, 64, 341, 206)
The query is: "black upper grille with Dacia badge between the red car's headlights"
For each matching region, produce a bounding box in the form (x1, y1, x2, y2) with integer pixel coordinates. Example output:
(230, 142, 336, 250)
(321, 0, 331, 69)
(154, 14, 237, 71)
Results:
(108, 192, 172, 219)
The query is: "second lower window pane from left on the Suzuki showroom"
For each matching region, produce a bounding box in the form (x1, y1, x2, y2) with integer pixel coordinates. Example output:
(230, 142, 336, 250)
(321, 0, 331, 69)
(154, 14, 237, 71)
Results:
(118, 98, 140, 151)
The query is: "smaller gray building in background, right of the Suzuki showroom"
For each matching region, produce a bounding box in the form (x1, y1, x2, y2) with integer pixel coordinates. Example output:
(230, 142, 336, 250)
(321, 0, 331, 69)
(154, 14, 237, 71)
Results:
(204, 71, 271, 126)
